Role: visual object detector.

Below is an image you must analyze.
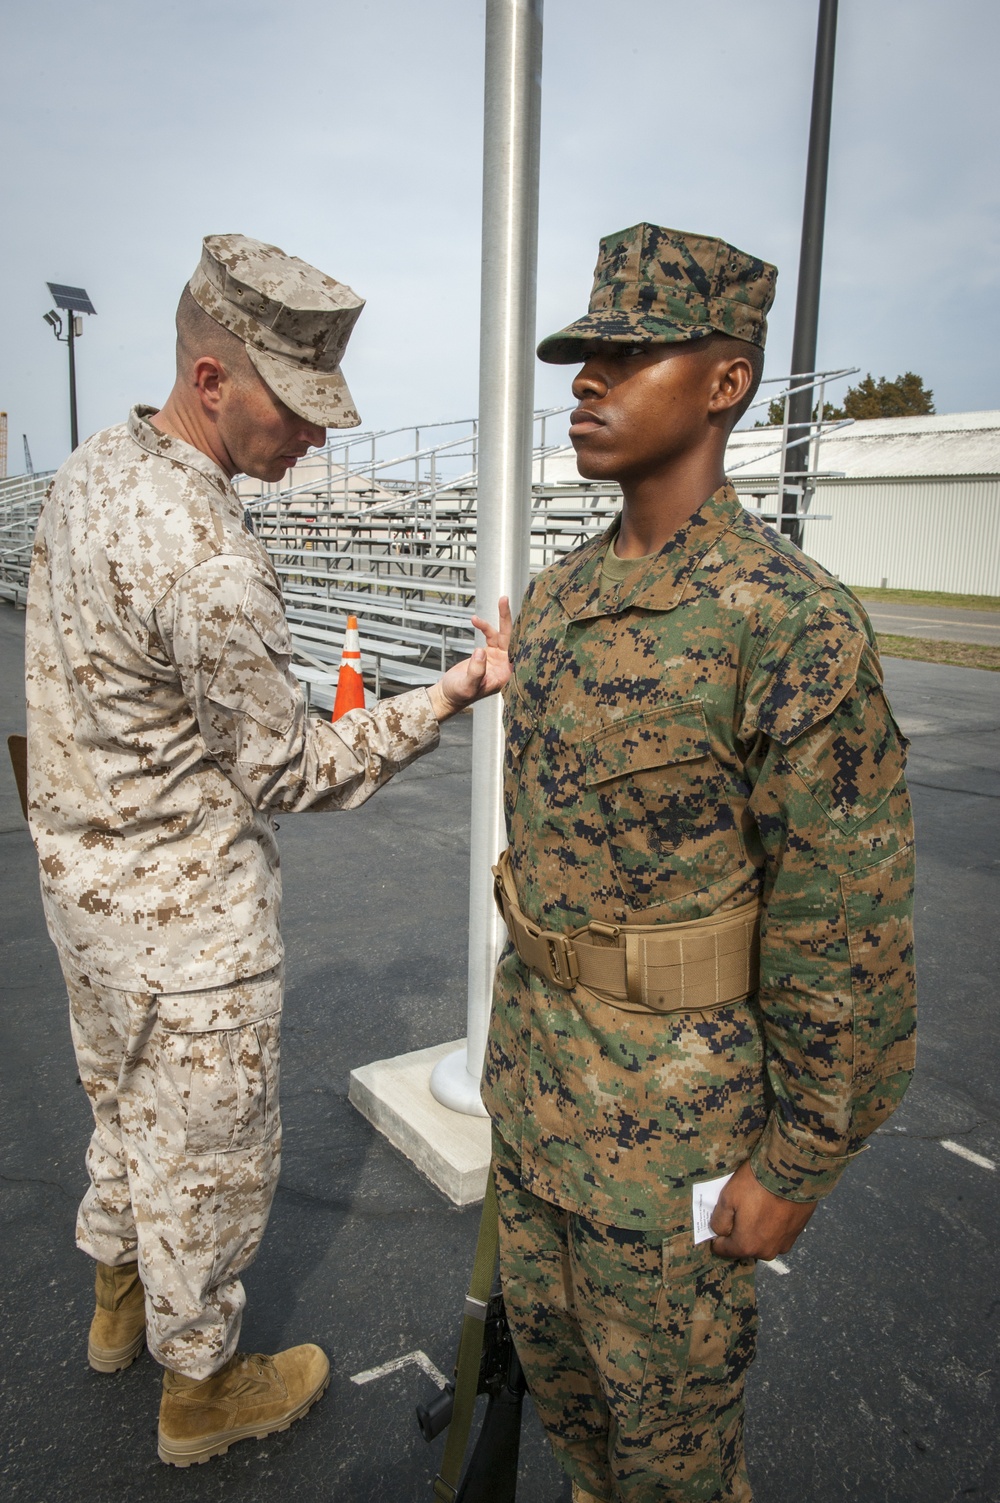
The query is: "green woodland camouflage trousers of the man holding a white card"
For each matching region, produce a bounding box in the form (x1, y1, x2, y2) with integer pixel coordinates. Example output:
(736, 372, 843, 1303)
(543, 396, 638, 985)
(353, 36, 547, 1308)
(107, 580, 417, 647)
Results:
(493, 1132, 756, 1503)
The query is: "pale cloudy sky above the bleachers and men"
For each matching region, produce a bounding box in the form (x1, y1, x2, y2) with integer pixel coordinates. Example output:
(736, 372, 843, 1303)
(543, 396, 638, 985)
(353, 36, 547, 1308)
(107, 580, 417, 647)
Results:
(0, 0, 1000, 473)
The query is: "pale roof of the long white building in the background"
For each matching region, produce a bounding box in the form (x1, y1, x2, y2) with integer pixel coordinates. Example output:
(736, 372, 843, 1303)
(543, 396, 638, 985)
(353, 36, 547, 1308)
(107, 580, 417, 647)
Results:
(534, 410, 1000, 484)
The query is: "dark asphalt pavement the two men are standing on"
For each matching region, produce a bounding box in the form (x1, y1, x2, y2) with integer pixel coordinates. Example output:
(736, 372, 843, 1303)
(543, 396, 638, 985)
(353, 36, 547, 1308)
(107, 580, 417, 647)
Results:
(0, 606, 1000, 1503)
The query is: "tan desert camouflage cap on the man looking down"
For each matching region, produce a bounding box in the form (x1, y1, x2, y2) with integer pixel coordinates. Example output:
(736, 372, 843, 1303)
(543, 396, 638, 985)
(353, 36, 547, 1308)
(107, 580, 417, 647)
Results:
(188, 234, 364, 428)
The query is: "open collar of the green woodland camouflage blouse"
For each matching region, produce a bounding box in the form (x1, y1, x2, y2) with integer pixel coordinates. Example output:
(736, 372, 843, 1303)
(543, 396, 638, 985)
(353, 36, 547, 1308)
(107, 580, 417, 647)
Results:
(552, 481, 743, 621)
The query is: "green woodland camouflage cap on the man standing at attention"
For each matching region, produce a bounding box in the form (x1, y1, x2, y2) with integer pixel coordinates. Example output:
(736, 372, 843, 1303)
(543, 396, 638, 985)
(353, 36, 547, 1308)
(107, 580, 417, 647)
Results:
(538, 224, 777, 365)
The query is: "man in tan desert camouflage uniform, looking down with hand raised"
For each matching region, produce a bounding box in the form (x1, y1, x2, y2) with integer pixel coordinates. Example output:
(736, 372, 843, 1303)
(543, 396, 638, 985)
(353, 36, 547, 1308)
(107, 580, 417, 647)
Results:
(26, 234, 507, 1464)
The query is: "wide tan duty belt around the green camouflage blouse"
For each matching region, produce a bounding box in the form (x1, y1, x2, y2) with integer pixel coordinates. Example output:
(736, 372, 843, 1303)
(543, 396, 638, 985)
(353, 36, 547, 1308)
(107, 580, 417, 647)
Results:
(493, 851, 761, 1013)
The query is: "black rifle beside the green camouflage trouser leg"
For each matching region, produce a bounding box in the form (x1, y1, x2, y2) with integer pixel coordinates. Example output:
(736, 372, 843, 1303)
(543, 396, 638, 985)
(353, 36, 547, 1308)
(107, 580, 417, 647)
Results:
(417, 1293, 526, 1503)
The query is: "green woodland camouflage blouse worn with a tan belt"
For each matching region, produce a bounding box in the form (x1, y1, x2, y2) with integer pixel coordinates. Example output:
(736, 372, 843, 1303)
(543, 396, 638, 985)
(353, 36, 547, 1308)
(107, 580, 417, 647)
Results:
(484, 485, 916, 1228)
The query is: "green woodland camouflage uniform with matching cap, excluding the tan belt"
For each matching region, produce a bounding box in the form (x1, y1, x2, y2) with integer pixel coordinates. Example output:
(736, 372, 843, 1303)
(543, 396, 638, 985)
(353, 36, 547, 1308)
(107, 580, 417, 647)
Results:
(484, 225, 914, 1503)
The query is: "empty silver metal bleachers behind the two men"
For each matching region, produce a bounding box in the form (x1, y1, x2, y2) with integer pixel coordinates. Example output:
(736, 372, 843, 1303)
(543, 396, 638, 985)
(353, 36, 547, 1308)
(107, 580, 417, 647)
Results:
(0, 371, 850, 708)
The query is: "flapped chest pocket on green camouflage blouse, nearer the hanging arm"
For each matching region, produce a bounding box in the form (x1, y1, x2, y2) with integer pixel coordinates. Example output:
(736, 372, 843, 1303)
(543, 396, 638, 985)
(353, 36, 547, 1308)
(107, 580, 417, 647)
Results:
(586, 700, 744, 908)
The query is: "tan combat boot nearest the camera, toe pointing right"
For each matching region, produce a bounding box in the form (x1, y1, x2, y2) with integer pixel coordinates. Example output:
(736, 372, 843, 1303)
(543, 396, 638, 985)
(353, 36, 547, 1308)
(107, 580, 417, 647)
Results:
(156, 1345, 329, 1467)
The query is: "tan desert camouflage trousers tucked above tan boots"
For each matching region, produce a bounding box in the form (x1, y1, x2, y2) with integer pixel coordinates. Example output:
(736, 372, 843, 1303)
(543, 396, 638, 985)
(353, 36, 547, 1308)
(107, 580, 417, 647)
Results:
(63, 959, 281, 1378)
